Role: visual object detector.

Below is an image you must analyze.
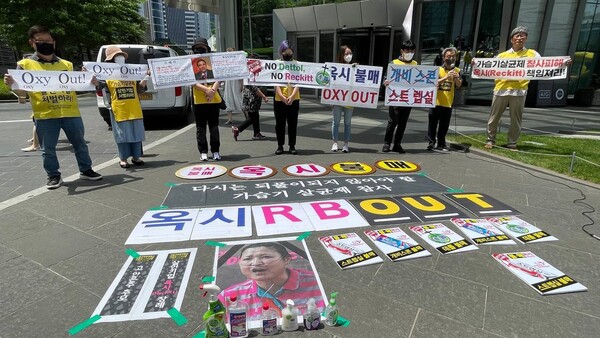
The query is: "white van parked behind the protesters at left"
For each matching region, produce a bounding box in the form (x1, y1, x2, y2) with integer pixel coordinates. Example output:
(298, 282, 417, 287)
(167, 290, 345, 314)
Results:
(96, 45, 191, 125)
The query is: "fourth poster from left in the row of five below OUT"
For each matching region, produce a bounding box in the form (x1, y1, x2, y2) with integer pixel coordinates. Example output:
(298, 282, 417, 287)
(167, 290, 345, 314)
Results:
(450, 218, 517, 245)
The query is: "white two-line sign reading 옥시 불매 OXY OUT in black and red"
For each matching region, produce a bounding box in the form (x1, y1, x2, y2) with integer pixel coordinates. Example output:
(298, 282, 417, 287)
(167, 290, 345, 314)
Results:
(321, 63, 383, 108)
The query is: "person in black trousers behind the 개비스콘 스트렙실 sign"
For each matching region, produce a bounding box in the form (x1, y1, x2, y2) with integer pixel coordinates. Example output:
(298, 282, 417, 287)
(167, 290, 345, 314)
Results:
(381, 40, 418, 154)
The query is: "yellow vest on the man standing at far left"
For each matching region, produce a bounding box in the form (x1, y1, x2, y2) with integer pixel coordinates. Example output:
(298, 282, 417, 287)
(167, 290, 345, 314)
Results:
(17, 58, 81, 120)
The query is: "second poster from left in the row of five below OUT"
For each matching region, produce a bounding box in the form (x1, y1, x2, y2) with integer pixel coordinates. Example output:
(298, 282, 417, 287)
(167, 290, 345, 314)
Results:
(365, 227, 431, 262)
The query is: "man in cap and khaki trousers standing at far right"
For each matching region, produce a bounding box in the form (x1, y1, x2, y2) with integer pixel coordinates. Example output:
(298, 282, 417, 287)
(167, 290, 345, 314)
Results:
(485, 26, 540, 151)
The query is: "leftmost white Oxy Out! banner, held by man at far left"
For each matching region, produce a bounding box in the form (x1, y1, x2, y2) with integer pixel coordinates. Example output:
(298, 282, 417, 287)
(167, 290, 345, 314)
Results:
(8, 69, 96, 92)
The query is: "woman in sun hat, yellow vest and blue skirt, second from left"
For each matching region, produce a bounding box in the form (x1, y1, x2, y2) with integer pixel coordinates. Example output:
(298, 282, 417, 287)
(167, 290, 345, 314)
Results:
(97, 45, 149, 169)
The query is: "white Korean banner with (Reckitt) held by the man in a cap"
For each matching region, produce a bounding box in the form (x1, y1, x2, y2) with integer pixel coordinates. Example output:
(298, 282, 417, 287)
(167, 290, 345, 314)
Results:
(471, 56, 570, 80)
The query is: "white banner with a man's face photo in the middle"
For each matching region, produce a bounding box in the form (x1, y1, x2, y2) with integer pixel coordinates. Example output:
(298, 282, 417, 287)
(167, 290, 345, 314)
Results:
(148, 51, 248, 88)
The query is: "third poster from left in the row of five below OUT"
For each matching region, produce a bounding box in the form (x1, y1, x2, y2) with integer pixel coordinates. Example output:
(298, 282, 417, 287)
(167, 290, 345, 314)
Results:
(409, 223, 478, 254)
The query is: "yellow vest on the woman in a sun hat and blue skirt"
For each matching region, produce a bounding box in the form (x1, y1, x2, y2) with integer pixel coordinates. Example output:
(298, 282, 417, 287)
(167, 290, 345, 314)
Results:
(106, 80, 144, 122)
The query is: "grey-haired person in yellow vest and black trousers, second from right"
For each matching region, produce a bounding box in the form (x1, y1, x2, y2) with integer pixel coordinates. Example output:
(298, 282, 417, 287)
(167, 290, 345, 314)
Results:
(427, 47, 462, 151)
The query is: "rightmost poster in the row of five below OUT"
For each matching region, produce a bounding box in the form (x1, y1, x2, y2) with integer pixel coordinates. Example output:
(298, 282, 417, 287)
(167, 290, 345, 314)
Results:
(487, 216, 558, 243)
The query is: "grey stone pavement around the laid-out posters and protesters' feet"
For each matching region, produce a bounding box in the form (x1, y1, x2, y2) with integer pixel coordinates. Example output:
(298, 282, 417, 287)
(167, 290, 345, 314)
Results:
(0, 96, 600, 338)
